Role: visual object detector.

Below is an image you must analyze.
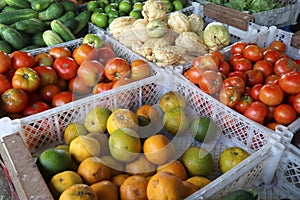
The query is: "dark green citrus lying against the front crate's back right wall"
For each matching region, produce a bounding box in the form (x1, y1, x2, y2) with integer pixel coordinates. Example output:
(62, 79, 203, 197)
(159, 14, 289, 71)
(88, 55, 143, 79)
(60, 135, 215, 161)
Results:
(190, 116, 218, 142)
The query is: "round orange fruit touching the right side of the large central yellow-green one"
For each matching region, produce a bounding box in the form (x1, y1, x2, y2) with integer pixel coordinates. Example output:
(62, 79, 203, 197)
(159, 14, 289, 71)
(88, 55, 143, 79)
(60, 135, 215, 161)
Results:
(143, 134, 175, 165)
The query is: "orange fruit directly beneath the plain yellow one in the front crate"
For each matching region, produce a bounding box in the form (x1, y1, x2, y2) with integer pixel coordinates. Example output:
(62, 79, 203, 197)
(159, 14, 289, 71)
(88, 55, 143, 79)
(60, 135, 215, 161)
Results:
(77, 157, 111, 185)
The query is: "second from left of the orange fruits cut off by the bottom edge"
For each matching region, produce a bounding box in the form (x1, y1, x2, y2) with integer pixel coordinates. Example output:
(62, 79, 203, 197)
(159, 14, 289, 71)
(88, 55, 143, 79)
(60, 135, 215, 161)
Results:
(90, 180, 119, 200)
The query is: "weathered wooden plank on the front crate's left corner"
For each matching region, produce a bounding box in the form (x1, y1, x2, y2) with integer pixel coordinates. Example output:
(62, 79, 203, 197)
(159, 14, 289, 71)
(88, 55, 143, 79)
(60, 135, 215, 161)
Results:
(0, 133, 53, 200)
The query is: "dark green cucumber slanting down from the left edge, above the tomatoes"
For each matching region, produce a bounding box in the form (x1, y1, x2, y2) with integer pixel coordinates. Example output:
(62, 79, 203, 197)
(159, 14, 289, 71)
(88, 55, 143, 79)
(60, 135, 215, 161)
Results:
(0, 24, 29, 50)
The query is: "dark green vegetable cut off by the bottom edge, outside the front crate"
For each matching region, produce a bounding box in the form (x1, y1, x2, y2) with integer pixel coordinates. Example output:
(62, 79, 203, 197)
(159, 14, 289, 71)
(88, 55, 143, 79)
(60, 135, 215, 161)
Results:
(221, 190, 258, 200)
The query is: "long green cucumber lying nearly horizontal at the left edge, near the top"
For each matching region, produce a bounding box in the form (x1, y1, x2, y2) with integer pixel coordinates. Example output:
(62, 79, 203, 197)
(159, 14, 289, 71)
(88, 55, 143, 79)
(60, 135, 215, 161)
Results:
(0, 8, 38, 25)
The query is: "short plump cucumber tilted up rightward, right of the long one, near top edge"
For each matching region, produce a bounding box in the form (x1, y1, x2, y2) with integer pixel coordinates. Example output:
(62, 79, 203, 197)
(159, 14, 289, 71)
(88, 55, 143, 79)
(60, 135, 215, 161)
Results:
(38, 2, 64, 21)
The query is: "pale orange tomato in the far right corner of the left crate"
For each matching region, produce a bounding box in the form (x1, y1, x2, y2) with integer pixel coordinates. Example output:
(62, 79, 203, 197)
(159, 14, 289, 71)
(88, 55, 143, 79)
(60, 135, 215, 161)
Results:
(130, 59, 151, 81)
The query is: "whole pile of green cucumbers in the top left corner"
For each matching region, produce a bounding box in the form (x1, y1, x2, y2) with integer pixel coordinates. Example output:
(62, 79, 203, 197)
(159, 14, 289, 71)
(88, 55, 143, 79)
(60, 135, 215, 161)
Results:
(0, 0, 91, 53)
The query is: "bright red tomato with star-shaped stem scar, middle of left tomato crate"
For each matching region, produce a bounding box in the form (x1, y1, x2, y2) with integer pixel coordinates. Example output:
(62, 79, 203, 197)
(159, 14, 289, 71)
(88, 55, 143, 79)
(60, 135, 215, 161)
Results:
(53, 56, 78, 80)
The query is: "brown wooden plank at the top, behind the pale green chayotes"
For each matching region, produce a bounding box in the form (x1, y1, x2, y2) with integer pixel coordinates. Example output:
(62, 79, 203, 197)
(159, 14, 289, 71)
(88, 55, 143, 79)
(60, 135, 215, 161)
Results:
(203, 3, 254, 31)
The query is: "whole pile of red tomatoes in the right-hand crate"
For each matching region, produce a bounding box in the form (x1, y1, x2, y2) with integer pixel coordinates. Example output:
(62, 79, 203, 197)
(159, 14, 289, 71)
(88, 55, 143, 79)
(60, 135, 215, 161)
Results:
(184, 41, 300, 130)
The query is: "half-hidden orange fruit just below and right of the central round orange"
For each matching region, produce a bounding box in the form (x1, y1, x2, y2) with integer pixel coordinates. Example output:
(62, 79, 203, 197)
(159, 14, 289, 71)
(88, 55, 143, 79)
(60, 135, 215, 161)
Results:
(157, 160, 187, 180)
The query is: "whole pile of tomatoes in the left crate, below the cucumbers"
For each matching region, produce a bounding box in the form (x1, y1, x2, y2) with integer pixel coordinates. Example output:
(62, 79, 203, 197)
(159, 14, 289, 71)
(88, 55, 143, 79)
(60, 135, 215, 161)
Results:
(0, 42, 151, 118)
